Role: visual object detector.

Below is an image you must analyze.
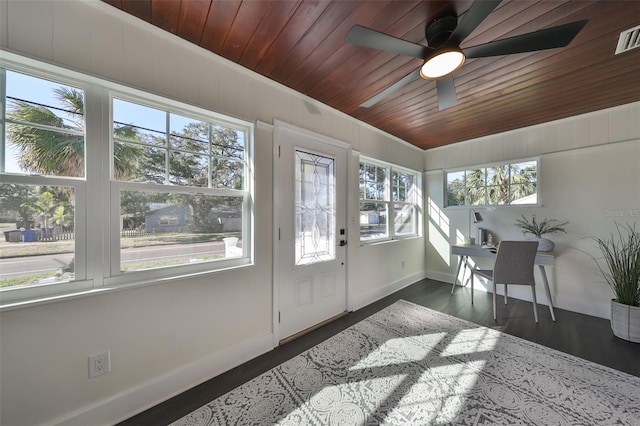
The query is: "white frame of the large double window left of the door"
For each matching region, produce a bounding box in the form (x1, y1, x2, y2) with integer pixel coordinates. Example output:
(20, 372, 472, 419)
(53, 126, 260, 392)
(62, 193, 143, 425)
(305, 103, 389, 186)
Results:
(0, 50, 255, 311)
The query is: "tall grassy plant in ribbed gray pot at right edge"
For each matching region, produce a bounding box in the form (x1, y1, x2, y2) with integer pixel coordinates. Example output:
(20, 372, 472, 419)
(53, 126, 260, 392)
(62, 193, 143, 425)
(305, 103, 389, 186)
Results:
(595, 223, 640, 343)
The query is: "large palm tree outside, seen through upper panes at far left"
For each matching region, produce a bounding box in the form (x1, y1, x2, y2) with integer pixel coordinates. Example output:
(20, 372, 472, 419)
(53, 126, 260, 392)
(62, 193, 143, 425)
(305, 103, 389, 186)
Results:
(7, 86, 141, 178)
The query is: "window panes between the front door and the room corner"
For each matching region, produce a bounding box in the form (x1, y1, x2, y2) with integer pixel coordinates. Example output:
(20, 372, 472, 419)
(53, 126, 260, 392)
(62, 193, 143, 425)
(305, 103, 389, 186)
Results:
(359, 159, 420, 242)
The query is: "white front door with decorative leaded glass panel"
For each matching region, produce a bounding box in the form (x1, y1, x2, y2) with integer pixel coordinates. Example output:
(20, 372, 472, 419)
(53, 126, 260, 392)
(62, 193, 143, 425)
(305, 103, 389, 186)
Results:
(274, 122, 349, 339)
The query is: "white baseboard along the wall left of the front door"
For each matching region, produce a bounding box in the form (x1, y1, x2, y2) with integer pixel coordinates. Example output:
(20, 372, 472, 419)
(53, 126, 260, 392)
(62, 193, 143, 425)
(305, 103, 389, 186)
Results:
(52, 333, 273, 426)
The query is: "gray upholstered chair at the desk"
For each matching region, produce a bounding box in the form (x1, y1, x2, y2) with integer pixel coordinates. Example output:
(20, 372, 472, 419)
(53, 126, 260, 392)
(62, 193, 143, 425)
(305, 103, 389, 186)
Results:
(471, 241, 538, 322)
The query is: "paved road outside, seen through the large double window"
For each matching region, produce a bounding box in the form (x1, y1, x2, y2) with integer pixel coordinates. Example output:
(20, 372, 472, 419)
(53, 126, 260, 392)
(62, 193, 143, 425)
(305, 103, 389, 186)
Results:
(0, 241, 230, 278)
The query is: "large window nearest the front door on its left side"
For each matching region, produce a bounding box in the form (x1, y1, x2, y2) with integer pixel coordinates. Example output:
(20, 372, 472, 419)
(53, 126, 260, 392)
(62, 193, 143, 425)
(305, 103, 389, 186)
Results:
(111, 95, 249, 275)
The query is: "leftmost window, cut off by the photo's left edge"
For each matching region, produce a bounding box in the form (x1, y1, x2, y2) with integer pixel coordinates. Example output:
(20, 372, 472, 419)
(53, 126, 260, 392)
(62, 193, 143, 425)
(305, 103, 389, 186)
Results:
(0, 69, 85, 291)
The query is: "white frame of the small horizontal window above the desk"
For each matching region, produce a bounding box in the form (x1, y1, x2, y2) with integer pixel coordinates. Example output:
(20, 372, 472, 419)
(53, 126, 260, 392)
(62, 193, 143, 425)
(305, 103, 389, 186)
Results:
(442, 157, 542, 209)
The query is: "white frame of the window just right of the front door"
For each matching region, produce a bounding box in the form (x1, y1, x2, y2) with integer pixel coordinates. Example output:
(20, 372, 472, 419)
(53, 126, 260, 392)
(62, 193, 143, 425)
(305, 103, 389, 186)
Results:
(358, 156, 422, 245)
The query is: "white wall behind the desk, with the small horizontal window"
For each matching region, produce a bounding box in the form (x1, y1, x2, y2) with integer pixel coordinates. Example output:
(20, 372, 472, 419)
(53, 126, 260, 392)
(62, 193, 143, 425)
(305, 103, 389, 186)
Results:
(425, 103, 640, 318)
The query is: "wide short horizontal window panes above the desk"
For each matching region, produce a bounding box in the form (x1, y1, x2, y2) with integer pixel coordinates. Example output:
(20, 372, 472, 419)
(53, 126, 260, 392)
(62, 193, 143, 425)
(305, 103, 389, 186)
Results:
(445, 160, 538, 206)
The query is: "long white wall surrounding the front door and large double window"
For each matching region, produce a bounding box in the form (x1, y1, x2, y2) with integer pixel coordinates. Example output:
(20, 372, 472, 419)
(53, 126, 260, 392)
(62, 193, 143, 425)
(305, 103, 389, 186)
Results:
(0, 0, 425, 426)
